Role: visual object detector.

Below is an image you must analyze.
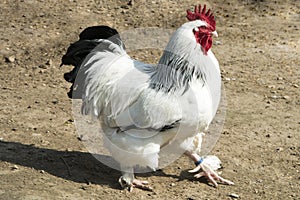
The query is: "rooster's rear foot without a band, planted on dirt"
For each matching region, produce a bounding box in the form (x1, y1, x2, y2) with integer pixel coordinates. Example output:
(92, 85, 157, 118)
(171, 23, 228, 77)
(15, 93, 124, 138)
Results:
(119, 168, 153, 192)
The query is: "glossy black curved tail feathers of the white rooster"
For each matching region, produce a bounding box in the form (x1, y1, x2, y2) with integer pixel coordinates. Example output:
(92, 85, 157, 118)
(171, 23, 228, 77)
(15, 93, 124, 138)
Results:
(61, 26, 125, 99)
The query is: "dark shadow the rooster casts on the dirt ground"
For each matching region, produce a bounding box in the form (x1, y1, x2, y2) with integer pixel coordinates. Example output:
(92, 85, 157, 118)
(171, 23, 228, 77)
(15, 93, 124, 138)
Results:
(0, 141, 200, 189)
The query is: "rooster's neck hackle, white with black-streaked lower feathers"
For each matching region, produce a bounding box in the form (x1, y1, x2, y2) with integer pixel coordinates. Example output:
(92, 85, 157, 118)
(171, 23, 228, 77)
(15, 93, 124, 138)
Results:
(150, 30, 205, 93)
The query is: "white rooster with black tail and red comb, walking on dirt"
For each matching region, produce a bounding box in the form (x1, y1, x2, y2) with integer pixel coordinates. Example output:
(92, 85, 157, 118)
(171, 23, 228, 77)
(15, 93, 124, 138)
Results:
(62, 5, 233, 191)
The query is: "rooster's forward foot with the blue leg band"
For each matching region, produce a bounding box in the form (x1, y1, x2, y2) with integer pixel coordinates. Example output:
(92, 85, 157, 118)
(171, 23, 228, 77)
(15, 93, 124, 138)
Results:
(185, 151, 234, 187)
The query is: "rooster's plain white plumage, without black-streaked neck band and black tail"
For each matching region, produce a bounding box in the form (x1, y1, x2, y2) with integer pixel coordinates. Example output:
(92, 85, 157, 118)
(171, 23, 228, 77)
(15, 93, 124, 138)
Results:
(79, 20, 221, 169)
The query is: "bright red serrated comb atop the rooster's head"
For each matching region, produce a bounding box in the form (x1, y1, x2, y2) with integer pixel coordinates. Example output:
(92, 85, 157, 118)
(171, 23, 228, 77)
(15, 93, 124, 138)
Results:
(186, 4, 216, 30)
